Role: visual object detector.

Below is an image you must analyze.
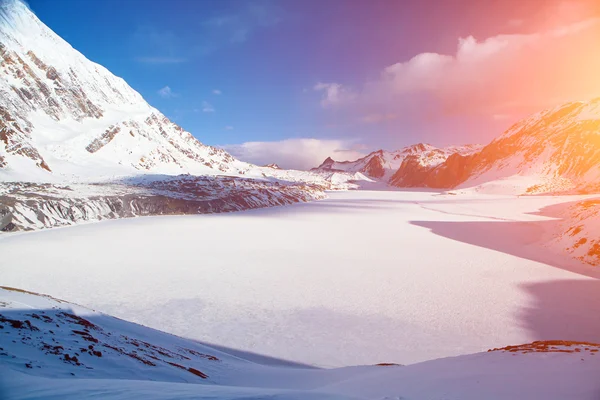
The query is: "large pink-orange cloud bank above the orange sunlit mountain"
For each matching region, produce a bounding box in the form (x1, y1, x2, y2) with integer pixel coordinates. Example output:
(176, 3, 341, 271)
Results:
(322, 18, 600, 123)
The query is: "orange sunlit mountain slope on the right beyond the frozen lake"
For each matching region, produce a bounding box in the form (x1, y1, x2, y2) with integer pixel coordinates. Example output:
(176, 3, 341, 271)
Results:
(390, 99, 600, 193)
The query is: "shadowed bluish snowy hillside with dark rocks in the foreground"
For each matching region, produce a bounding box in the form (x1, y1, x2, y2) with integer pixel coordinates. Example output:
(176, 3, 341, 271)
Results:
(0, 287, 600, 400)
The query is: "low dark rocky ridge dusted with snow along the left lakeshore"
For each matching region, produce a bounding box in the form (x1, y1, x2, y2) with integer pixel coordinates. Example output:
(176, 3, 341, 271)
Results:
(0, 176, 325, 232)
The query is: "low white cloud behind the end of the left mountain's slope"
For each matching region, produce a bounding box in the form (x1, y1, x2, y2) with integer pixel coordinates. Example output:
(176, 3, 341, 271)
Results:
(221, 138, 366, 170)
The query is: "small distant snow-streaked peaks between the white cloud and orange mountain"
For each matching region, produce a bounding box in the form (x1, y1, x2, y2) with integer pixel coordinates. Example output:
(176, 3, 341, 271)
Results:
(313, 143, 480, 182)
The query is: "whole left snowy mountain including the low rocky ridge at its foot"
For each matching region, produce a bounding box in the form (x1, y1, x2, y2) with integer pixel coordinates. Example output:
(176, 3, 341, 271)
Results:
(0, 0, 376, 231)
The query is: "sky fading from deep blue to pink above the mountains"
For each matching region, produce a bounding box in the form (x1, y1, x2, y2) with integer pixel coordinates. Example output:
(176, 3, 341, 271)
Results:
(29, 0, 600, 166)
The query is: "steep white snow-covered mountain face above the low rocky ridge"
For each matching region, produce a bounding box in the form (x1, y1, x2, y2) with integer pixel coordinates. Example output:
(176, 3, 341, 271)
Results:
(0, 0, 251, 179)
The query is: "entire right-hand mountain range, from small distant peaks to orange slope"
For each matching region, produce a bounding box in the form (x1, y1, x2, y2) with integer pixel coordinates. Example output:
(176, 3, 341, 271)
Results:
(313, 98, 600, 194)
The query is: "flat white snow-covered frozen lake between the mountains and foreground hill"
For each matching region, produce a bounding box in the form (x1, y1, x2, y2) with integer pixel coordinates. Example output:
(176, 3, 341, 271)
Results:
(0, 191, 600, 367)
